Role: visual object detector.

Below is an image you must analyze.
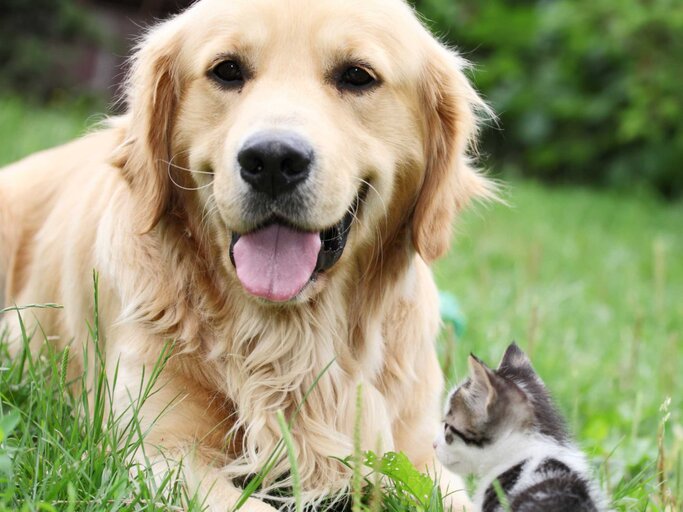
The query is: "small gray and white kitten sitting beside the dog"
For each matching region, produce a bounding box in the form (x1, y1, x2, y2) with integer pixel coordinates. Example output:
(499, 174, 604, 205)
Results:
(434, 343, 606, 512)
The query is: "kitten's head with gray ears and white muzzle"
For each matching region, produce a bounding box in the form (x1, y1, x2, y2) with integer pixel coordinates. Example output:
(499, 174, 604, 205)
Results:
(434, 343, 567, 474)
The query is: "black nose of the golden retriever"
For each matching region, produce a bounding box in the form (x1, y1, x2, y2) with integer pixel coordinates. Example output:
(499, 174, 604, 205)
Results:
(237, 132, 313, 198)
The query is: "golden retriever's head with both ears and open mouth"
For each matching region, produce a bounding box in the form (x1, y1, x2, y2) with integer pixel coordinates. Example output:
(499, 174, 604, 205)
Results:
(115, 0, 490, 302)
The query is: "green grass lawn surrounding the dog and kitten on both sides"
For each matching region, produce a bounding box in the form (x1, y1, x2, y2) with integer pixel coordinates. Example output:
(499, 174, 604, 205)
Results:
(0, 97, 683, 511)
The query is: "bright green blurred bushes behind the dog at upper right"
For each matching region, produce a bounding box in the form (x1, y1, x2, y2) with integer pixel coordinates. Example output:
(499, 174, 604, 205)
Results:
(415, 0, 683, 197)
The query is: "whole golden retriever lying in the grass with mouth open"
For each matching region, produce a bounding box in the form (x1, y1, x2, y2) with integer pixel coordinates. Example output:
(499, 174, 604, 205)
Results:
(0, 0, 492, 510)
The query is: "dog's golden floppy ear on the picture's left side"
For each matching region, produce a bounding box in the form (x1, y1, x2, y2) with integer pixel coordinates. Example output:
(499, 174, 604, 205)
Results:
(113, 17, 186, 233)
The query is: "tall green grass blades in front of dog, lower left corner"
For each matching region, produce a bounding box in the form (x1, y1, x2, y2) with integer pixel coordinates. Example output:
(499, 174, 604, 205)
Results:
(0, 285, 200, 512)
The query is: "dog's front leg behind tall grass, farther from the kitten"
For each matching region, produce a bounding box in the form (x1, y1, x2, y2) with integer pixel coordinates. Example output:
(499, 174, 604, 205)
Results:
(107, 337, 275, 512)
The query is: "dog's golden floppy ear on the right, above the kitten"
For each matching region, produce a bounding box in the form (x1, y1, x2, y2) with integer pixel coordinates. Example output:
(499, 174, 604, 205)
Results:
(412, 46, 495, 261)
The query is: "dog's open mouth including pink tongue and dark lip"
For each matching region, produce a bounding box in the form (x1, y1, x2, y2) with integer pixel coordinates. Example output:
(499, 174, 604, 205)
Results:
(230, 185, 368, 302)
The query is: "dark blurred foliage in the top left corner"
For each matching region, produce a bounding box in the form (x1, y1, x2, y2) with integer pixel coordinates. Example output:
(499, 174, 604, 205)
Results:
(0, 0, 102, 99)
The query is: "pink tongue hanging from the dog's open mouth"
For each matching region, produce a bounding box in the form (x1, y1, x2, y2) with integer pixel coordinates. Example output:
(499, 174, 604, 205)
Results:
(233, 224, 321, 302)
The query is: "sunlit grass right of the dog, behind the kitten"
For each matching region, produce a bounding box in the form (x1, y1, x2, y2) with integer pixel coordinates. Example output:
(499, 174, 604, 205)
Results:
(436, 183, 683, 510)
